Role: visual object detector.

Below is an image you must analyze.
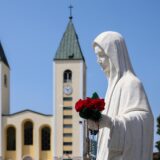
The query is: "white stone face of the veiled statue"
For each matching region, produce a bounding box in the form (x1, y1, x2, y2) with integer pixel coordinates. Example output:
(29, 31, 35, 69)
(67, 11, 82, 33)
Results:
(94, 46, 110, 75)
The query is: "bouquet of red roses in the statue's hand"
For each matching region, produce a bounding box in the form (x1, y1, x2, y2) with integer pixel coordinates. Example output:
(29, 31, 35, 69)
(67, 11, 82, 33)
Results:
(75, 92, 105, 121)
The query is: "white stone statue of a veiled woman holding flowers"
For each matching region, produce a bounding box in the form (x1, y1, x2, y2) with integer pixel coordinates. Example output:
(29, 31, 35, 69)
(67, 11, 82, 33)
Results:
(88, 32, 153, 160)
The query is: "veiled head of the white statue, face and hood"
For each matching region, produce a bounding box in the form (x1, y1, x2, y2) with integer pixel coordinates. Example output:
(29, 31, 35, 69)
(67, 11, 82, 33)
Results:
(93, 31, 133, 77)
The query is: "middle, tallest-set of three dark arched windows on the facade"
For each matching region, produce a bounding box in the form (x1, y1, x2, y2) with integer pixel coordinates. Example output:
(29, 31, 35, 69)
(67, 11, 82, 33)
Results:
(24, 121, 33, 145)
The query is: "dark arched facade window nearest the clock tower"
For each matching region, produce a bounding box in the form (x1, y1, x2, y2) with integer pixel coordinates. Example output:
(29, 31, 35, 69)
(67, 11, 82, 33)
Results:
(41, 127, 51, 151)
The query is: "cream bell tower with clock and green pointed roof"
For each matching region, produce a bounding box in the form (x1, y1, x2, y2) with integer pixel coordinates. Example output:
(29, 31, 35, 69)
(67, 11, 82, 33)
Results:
(53, 16, 86, 160)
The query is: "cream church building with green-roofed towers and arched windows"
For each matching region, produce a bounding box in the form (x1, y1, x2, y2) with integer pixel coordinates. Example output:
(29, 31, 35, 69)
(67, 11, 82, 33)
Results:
(0, 17, 87, 160)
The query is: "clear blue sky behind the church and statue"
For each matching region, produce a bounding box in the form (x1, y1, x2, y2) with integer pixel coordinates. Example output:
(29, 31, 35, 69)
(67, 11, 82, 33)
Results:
(0, 0, 160, 151)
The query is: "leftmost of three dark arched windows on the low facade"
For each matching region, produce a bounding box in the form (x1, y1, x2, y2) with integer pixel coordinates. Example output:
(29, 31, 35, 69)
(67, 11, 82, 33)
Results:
(7, 127, 16, 151)
